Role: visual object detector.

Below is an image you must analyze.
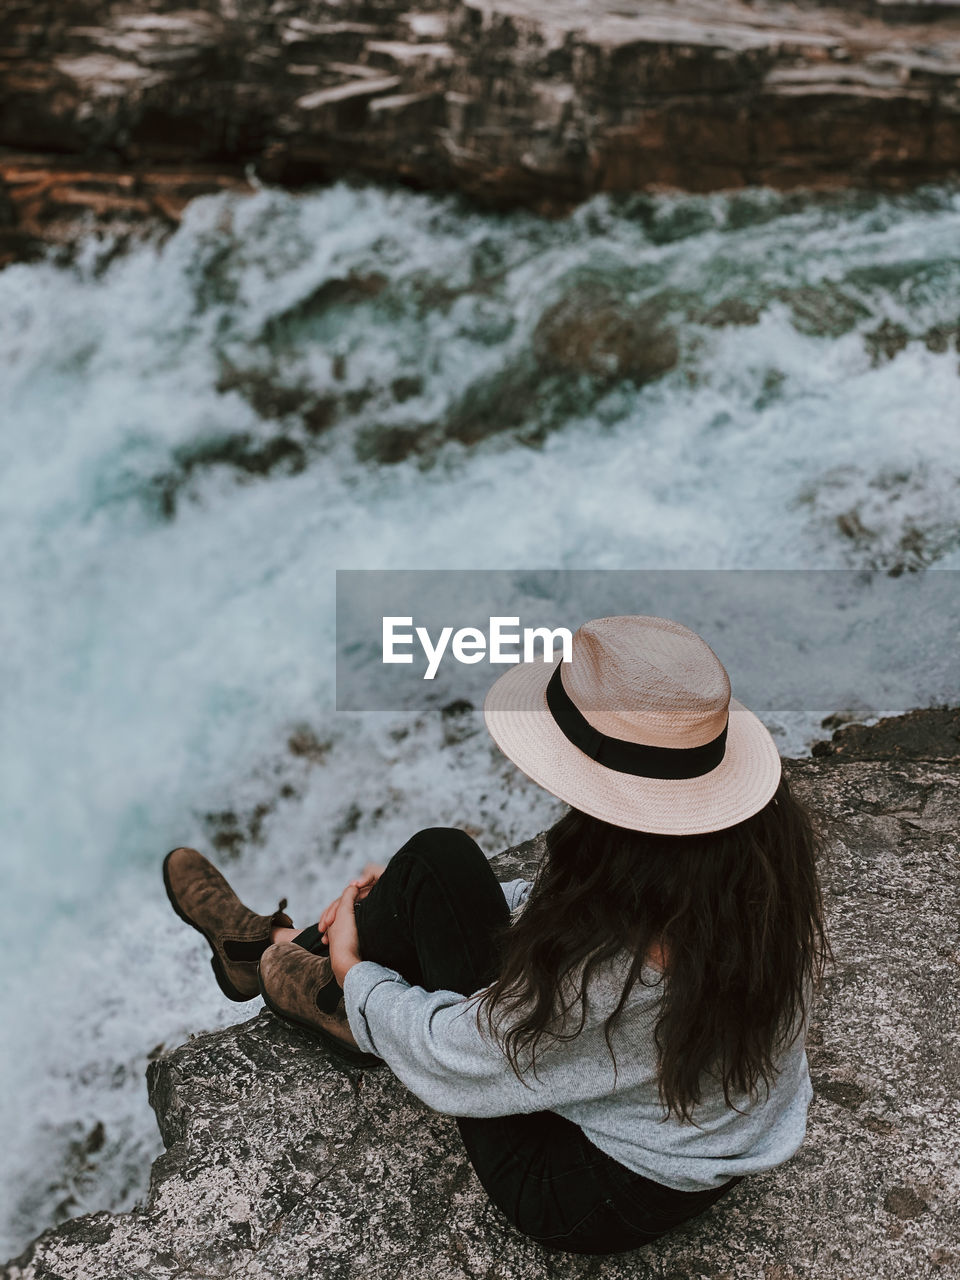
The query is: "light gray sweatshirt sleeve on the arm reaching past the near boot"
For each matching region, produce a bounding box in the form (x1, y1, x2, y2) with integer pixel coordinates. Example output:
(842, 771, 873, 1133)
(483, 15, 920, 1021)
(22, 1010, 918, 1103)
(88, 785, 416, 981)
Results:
(343, 960, 613, 1116)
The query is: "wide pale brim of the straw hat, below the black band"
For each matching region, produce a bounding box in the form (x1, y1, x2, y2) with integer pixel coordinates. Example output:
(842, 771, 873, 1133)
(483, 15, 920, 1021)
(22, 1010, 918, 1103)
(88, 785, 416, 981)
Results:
(484, 659, 781, 836)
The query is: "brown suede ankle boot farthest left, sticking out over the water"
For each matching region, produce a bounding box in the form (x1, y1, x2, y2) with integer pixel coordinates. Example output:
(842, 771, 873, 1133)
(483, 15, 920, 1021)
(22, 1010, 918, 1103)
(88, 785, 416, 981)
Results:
(164, 849, 293, 1001)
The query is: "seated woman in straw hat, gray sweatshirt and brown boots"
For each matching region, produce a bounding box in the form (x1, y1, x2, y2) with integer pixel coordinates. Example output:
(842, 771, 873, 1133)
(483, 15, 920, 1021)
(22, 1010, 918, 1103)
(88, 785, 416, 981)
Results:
(165, 617, 828, 1253)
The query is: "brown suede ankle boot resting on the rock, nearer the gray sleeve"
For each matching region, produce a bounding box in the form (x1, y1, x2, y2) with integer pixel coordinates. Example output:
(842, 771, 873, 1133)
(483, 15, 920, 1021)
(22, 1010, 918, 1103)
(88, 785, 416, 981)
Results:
(260, 942, 383, 1066)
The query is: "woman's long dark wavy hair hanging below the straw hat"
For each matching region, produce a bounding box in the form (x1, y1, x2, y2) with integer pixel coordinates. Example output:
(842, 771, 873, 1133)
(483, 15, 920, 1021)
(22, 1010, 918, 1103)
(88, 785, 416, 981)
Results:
(477, 777, 831, 1120)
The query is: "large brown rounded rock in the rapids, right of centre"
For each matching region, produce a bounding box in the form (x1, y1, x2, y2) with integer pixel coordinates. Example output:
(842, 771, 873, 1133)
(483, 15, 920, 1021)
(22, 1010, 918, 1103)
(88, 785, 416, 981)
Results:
(532, 283, 680, 385)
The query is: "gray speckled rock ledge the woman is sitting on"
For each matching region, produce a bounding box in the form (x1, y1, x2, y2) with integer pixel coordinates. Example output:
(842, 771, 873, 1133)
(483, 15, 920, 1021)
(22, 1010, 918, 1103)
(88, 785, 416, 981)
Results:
(0, 712, 960, 1280)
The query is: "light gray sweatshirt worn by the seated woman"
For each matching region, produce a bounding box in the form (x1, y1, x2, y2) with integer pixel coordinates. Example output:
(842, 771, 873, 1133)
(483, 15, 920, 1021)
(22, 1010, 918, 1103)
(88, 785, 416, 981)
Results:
(343, 879, 813, 1190)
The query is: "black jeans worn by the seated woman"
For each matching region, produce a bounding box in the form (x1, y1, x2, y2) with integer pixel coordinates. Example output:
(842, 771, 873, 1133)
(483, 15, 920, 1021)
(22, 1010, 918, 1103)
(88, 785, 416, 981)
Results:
(356, 827, 740, 1253)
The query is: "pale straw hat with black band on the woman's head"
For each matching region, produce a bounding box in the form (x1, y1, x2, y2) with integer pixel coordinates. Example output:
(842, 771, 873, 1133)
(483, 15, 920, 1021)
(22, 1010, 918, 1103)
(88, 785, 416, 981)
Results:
(484, 617, 781, 836)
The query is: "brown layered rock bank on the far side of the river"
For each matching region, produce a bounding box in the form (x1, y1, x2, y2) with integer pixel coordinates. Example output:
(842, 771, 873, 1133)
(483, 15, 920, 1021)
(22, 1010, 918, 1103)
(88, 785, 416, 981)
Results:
(0, 0, 960, 262)
